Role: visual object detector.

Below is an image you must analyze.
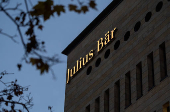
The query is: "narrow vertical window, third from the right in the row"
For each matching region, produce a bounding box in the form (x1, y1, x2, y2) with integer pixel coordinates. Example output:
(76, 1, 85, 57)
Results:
(136, 62, 142, 99)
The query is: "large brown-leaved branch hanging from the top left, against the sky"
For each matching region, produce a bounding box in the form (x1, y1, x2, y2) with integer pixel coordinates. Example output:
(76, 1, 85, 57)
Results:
(0, 0, 96, 74)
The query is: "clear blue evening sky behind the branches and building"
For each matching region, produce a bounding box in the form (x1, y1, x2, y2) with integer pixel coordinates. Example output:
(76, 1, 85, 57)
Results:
(0, 0, 112, 112)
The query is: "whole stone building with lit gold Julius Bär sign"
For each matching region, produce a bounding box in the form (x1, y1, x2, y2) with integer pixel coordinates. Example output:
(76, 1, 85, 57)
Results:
(62, 0, 170, 112)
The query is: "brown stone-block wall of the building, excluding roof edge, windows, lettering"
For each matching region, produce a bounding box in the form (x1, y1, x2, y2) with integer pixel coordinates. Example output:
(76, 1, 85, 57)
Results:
(62, 0, 170, 112)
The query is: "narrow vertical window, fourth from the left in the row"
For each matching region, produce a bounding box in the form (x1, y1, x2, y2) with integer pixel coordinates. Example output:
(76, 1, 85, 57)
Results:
(114, 80, 120, 112)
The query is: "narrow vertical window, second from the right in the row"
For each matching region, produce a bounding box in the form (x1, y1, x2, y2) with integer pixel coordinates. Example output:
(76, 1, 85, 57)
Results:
(147, 52, 155, 90)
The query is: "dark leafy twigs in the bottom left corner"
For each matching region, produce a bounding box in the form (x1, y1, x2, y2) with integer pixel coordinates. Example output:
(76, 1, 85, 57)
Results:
(0, 71, 33, 112)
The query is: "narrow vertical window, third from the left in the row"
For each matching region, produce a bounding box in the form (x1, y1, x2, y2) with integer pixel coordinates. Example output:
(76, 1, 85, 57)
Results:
(104, 89, 109, 112)
